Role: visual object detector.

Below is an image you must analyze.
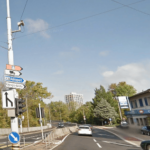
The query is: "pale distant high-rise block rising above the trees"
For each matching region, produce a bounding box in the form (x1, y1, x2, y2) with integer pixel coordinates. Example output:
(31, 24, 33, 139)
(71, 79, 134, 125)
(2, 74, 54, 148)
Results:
(65, 92, 83, 109)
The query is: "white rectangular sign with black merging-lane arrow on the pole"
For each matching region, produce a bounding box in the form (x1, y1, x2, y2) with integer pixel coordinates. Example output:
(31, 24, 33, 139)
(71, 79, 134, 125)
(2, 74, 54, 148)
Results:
(2, 90, 15, 108)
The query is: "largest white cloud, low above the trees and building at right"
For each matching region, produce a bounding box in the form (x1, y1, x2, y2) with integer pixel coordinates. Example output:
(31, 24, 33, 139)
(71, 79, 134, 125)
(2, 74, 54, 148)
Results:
(101, 63, 150, 92)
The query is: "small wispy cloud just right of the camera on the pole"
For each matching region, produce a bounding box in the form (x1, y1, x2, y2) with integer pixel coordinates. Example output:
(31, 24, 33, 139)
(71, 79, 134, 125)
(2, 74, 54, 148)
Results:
(25, 19, 50, 38)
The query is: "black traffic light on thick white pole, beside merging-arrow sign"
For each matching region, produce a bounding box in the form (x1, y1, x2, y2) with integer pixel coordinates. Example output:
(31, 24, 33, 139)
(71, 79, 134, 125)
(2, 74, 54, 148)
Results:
(15, 98, 26, 116)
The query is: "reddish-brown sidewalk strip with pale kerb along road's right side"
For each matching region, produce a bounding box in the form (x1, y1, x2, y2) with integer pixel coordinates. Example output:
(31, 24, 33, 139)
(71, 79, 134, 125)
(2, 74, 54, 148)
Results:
(95, 126, 143, 147)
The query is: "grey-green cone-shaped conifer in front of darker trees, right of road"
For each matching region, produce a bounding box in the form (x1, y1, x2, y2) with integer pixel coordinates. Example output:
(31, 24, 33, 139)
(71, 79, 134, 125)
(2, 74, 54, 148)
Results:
(94, 98, 118, 124)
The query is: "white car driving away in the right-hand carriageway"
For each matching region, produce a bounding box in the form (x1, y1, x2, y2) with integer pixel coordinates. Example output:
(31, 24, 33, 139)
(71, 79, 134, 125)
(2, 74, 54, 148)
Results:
(78, 125, 92, 136)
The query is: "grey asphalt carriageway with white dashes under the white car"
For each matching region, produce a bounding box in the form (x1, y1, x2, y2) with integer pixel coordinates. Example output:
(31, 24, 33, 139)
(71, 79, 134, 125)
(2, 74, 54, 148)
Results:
(54, 128, 141, 150)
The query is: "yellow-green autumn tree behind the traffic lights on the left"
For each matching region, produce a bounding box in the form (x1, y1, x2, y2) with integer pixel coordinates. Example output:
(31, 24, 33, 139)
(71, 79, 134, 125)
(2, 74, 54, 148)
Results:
(17, 81, 52, 127)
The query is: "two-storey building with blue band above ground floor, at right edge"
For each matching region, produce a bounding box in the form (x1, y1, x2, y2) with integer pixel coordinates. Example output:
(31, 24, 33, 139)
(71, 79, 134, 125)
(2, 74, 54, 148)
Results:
(125, 89, 150, 128)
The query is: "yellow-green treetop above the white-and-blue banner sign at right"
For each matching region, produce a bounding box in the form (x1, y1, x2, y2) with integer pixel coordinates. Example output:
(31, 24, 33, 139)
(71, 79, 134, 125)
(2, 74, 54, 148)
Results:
(108, 82, 136, 97)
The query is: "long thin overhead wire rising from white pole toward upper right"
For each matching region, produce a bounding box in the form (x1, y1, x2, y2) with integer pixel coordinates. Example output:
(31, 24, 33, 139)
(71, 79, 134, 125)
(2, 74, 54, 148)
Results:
(14, 0, 144, 39)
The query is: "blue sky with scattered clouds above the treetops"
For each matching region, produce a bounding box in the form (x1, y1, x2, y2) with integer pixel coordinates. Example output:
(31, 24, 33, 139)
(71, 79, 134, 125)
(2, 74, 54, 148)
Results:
(0, 0, 150, 103)
